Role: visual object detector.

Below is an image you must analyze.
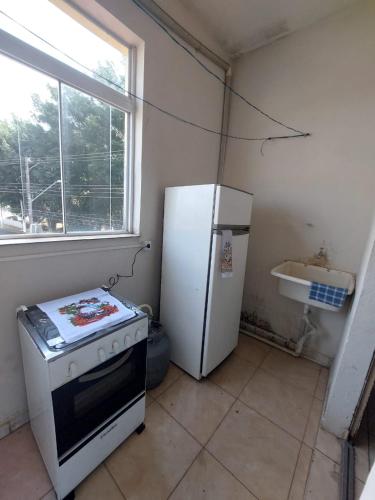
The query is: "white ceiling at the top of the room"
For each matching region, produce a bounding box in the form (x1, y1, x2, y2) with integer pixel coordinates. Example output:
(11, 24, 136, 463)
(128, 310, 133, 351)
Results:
(170, 0, 355, 57)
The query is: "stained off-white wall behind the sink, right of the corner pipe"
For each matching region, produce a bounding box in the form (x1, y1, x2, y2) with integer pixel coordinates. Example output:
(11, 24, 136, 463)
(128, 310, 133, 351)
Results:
(224, 0, 375, 363)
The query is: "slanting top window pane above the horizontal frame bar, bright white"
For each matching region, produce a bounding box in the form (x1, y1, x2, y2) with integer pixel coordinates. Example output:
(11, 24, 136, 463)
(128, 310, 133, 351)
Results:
(0, 0, 129, 93)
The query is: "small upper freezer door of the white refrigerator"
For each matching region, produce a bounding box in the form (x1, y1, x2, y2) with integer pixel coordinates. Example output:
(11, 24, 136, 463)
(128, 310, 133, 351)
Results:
(214, 186, 253, 226)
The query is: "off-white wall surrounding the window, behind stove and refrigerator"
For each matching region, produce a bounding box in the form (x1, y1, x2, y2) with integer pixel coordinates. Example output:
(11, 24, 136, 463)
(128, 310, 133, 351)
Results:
(0, 0, 223, 436)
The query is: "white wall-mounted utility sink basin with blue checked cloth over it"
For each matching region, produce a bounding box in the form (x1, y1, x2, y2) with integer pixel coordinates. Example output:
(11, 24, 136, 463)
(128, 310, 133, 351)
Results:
(271, 260, 355, 311)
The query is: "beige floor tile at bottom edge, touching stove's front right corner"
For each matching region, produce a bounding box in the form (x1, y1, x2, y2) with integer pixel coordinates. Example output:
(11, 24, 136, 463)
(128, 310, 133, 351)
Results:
(106, 402, 201, 500)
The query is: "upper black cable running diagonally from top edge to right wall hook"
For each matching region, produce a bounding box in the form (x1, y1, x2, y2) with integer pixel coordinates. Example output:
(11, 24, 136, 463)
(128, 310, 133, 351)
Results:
(132, 0, 310, 137)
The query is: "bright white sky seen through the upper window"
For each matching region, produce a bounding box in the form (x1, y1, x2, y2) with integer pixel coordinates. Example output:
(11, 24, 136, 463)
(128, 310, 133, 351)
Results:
(0, 0, 126, 119)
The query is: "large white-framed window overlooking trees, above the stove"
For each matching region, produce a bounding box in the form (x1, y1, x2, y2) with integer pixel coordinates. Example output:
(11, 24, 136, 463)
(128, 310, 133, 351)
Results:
(0, 0, 135, 238)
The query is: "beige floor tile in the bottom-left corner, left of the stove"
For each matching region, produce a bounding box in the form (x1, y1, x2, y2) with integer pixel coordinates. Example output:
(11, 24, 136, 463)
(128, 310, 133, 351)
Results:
(0, 425, 52, 500)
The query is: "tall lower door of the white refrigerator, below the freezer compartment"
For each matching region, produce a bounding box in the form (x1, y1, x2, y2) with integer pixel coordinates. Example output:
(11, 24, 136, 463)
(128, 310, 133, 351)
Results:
(202, 231, 249, 376)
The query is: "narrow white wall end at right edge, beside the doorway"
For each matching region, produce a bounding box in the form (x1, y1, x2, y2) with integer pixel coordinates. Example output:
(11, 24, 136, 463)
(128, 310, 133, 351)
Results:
(322, 215, 375, 439)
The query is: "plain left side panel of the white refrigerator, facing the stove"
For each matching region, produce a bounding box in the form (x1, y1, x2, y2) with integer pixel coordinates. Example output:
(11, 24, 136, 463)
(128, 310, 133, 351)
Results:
(160, 184, 215, 379)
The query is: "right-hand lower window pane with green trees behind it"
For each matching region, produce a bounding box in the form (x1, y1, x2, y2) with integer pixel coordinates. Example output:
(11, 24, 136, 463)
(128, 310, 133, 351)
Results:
(62, 85, 127, 232)
